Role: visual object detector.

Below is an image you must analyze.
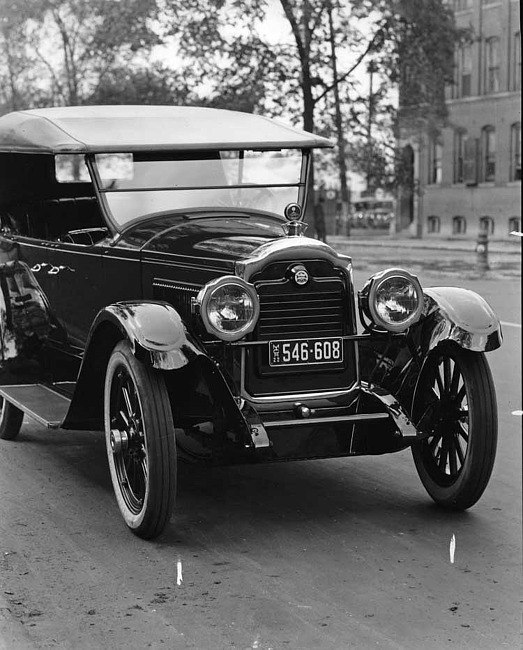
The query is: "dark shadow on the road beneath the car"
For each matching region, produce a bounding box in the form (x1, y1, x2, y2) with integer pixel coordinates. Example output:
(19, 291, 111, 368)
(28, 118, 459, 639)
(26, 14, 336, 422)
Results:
(15, 428, 482, 548)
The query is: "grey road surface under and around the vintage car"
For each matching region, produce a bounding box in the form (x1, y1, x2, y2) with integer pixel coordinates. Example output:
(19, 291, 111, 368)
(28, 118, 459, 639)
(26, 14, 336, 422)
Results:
(0, 244, 522, 650)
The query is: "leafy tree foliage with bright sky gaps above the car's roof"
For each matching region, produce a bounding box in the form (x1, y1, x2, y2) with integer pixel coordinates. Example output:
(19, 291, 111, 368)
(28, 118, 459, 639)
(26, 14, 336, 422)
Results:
(0, 0, 469, 195)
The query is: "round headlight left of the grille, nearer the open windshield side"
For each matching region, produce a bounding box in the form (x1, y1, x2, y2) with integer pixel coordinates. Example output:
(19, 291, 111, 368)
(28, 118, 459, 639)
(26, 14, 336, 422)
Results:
(196, 276, 260, 341)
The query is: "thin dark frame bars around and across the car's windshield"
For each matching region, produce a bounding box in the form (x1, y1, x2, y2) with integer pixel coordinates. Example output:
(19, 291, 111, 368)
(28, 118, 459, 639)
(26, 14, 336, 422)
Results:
(85, 147, 311, 235)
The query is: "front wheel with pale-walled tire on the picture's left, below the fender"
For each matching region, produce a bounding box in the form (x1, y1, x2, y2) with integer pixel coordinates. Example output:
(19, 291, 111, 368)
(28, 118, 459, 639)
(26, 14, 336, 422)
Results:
(104, 341, 177, 539)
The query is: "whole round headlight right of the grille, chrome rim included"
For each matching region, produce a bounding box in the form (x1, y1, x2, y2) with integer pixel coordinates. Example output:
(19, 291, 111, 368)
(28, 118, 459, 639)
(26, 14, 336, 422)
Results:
(360, 269, 423, 332)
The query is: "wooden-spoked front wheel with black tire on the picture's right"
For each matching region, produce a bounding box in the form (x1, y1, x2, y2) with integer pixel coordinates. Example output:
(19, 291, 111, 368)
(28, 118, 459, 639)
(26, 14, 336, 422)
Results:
(412, 344, 498, 510)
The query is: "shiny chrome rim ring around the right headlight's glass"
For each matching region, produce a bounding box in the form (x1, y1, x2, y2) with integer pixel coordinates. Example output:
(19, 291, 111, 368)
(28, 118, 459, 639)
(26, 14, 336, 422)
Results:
(361, 268, 424, 334)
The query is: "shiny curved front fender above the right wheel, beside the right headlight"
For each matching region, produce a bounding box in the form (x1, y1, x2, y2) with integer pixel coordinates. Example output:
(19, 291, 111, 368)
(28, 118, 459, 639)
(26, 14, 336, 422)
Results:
(422, 287, 503, 352)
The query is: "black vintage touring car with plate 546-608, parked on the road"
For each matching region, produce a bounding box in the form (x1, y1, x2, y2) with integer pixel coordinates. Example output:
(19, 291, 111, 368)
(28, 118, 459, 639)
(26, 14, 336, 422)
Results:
(0, 106, 501, 538)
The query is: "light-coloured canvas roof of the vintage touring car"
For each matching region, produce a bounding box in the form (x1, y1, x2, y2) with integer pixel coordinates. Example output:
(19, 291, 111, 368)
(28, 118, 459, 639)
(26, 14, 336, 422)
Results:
(0, 106, 332, 153)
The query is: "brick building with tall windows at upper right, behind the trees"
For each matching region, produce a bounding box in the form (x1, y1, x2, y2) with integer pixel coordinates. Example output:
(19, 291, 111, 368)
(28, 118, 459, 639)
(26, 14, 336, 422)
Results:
(398, 0, 521, 239)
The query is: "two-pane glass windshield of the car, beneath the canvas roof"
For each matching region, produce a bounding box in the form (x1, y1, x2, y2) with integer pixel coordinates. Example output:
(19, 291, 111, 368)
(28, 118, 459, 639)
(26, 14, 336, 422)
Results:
(94, 149, 304, 228)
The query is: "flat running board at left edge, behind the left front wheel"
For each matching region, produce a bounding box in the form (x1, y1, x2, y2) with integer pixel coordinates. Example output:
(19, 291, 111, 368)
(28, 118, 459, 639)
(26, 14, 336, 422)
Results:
(0, 384, 71, 429)
